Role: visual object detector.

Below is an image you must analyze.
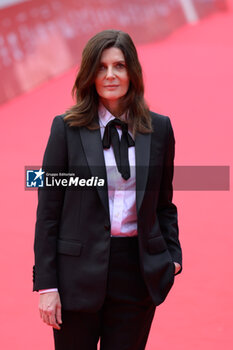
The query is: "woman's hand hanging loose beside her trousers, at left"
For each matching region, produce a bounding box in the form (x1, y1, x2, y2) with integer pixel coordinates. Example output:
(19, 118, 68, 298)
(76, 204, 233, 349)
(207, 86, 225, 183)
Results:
(39, 292, 62, 329)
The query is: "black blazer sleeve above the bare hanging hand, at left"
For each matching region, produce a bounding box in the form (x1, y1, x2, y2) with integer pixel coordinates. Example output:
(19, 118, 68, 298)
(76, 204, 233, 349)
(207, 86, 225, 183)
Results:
(33, 116, 67, 291)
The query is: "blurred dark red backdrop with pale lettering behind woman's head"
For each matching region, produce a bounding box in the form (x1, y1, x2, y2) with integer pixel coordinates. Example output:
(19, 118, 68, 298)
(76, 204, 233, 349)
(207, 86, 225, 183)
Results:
(0, 0, 227, 103)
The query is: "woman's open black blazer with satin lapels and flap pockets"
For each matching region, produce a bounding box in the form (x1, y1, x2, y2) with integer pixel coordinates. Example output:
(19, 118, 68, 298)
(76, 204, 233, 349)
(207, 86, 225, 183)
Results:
(33, 112, 182, 311)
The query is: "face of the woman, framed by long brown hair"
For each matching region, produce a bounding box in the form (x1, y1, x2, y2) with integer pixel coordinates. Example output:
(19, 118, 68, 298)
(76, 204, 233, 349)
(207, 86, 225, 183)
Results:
(95, 47, 129, 105)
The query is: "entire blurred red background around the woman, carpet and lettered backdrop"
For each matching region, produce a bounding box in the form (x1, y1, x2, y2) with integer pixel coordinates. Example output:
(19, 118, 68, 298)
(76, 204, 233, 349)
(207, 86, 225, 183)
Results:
(0, 0, 233, 350)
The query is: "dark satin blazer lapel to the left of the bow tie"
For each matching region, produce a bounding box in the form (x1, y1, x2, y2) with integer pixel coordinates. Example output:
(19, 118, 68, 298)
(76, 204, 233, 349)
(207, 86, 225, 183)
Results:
(80, 127, 109, 216)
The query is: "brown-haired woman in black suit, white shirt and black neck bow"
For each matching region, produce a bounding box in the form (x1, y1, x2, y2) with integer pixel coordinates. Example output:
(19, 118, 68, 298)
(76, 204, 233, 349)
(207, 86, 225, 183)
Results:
(34, 30, 182, 350)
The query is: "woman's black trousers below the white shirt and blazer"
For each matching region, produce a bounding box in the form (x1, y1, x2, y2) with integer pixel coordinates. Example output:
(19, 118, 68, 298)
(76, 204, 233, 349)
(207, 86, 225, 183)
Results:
(53, 237, 155, 350)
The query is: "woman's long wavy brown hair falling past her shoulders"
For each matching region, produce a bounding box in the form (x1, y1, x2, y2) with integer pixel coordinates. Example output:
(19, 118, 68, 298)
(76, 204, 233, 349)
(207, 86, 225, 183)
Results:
(64, 30, 152, 135)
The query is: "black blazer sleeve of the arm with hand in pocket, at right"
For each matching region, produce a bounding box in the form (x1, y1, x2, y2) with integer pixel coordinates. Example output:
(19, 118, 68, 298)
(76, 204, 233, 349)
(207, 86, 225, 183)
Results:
(157, 117, 182, 275)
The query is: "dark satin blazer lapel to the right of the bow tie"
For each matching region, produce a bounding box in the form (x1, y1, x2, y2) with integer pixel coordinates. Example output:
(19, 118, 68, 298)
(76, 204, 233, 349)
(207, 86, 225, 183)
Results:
(135, 133, 151, 213)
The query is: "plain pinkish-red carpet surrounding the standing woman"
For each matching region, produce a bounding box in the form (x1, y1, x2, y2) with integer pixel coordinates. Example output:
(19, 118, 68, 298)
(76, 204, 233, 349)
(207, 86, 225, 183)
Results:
(0, 4, 233, 350)
